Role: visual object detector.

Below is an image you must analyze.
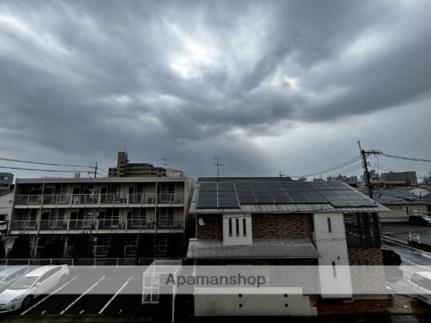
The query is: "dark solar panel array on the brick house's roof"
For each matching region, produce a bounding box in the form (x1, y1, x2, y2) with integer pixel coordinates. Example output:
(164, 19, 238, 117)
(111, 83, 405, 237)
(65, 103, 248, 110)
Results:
(197, 180, 375, 209)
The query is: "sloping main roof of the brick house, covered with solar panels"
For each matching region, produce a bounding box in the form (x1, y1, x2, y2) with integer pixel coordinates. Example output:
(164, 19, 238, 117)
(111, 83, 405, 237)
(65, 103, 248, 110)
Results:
(190, 177, 386, 214)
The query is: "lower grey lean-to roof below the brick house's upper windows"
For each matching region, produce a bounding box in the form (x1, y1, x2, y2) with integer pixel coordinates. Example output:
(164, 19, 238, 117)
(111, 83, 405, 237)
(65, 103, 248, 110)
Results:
(187, 239, 319, 259)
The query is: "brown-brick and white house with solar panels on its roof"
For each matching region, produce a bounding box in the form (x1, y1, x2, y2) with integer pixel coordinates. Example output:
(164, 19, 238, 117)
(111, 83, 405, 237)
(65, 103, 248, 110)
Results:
(187, 177, 385, 316)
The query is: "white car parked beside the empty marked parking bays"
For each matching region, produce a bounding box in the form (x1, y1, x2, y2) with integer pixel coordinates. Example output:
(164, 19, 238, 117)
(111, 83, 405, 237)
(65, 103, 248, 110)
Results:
(0, 265, 69, 312)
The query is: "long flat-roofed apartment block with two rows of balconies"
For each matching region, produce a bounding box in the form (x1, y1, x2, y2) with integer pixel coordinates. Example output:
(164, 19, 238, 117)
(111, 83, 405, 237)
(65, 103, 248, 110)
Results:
(9, 176, 192, 258)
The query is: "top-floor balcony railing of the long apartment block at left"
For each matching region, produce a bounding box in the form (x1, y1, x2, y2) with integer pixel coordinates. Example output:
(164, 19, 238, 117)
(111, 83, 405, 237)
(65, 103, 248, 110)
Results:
(15, 192, 184, 205)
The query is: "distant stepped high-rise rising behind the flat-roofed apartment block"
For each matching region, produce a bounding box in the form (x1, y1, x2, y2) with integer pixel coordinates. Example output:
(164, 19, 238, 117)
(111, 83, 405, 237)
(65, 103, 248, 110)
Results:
(108, 151, 168, 177)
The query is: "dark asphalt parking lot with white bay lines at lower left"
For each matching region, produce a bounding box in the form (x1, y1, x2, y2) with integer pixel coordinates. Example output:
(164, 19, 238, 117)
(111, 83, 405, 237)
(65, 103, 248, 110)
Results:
(1, 268, 142, 320)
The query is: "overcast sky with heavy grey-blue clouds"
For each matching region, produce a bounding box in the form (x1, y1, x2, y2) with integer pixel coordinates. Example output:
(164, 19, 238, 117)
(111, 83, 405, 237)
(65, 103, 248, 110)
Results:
(0, 0, 431, 177)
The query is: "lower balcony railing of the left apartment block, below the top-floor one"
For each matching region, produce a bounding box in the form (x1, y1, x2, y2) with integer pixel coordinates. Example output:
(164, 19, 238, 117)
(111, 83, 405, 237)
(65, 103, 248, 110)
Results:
(10, 218, 184, 232)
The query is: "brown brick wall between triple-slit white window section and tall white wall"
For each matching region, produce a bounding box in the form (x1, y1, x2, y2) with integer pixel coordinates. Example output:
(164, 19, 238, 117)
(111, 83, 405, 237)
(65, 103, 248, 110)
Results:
(252, 214, 313, 239)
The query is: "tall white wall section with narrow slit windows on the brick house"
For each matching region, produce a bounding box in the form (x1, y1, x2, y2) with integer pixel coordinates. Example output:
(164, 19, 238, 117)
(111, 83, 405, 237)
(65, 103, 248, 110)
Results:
(313, 213, 352, 298)
